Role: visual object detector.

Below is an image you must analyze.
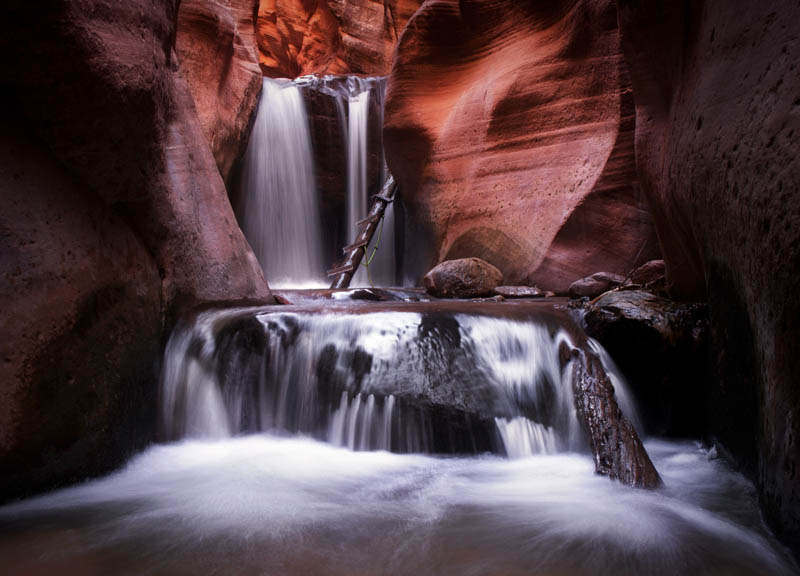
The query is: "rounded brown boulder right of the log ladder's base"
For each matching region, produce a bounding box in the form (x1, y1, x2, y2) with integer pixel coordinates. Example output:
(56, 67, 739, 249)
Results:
(423, 258, 503, 298)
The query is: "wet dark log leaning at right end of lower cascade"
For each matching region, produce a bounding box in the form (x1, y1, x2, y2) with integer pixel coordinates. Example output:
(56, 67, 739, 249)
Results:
(572, 352, 661, 488)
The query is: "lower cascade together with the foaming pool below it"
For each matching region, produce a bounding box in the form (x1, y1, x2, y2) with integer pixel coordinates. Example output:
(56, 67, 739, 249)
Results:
(0, 302, 797, 576)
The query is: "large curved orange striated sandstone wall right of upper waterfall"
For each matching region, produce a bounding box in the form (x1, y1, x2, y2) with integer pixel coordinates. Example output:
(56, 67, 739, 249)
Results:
(384, 0, 658, 293)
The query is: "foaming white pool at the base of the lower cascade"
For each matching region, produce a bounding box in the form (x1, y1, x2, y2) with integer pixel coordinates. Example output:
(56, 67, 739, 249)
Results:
(0, 435, 796, 576)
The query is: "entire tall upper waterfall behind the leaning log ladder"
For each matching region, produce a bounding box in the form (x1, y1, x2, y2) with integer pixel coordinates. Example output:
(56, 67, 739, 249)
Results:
(241, 76, 401, 288)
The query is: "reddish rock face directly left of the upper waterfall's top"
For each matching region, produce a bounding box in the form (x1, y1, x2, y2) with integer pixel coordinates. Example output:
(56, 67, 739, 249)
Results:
(175, 0, 262, 180)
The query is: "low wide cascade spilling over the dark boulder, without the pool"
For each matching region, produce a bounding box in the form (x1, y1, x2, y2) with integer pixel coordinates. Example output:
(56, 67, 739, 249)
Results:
(161, 309, 636, 457)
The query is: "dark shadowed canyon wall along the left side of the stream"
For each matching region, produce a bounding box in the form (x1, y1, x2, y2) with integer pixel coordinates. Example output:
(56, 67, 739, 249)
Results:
(0, 0, 271, 500)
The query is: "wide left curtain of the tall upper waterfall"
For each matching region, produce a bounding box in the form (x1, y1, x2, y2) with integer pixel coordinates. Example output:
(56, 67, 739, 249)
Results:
(236, 78, 324, 287)
